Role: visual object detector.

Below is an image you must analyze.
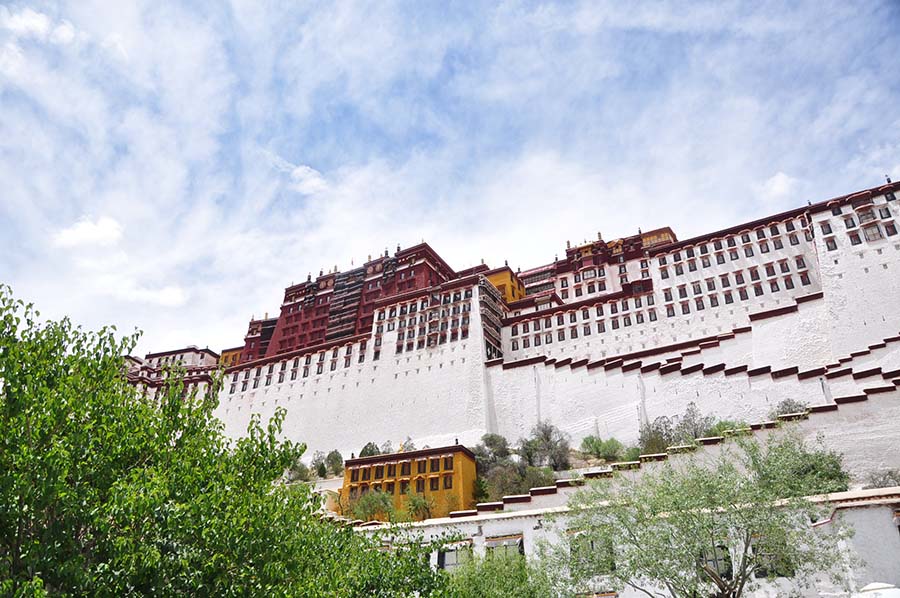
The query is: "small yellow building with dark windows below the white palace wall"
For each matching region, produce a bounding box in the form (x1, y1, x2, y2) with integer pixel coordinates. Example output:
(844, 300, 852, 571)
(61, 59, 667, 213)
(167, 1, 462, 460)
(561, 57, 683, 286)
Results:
(340, 444, 476, 517)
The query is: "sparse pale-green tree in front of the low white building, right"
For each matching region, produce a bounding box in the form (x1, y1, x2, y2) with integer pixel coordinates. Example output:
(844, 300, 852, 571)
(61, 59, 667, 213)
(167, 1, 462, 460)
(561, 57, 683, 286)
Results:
(551, 434, 852, 598)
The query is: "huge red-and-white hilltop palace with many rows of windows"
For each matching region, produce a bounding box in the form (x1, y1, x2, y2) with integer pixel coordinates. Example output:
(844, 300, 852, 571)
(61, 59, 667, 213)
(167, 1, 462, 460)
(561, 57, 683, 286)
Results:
(217, 183, 900, 466)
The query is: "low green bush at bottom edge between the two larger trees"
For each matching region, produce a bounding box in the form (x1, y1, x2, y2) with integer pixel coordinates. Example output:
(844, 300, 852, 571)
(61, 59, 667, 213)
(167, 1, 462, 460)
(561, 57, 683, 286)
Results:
(447, 555, 552, 598)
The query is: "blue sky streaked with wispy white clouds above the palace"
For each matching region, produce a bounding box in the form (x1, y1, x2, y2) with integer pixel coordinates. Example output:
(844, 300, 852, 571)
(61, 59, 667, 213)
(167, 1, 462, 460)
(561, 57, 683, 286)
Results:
(0, 0, 900, 352)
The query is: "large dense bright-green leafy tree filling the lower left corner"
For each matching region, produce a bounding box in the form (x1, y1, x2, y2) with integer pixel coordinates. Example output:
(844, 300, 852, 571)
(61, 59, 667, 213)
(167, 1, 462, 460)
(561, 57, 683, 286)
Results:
(0, 287, 444, 598)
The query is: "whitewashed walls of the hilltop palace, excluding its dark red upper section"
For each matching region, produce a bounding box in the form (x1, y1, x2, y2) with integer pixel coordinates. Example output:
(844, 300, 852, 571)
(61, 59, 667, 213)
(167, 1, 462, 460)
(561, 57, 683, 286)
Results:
(217, 185, 900, 455)
